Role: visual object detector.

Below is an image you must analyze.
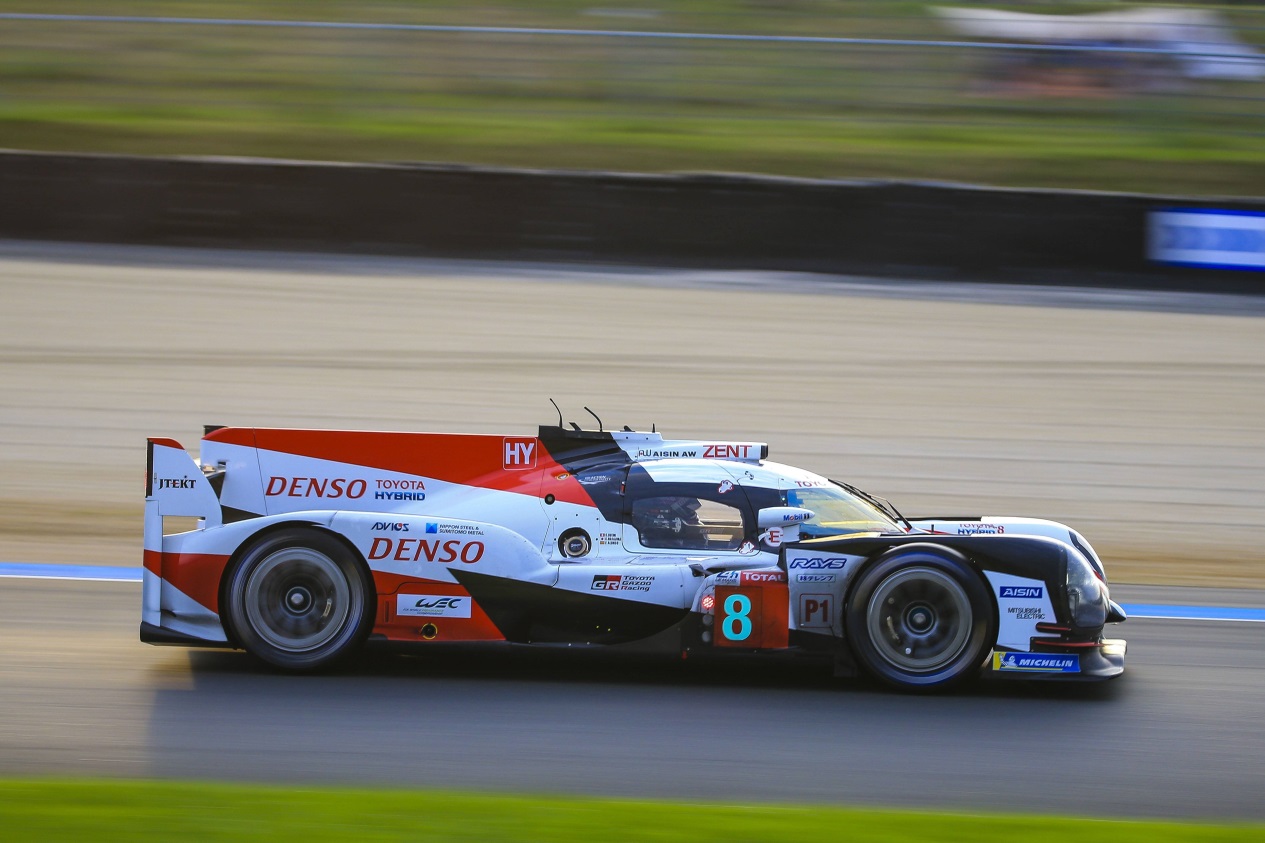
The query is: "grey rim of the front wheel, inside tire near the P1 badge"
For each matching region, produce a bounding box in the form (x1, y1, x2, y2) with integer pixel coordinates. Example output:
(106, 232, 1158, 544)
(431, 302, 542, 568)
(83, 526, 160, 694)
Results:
(865, 567, 972, 673)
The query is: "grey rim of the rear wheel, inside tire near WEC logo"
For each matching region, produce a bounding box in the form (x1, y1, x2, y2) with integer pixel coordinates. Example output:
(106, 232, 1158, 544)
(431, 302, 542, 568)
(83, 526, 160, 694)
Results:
(244, 547, 354, 653)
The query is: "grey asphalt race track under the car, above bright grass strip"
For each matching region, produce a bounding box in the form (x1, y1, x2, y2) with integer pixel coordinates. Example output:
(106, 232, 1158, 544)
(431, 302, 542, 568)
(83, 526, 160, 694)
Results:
(0, 580, 1265, 820)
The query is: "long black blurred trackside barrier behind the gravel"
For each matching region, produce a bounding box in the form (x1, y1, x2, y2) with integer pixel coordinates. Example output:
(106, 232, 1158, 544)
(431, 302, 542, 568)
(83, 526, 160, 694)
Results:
(0, 153, 1265, 292)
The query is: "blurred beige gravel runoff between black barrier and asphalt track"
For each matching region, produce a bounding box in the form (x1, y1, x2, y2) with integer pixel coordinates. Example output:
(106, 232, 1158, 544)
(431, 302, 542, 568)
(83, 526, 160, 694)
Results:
(0, 243, 1265, 587)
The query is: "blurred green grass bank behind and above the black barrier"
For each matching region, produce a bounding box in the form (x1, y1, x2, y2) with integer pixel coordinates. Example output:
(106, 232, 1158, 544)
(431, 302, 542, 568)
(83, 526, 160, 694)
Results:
(0, 0, 1265, 195)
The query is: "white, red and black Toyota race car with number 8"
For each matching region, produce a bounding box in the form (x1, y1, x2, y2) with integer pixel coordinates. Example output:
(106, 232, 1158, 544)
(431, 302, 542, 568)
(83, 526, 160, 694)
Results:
(140, 418, 1125, 690)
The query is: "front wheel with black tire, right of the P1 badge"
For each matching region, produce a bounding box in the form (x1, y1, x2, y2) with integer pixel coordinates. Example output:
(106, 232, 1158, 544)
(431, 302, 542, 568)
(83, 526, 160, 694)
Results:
(846, 546, 997, 691)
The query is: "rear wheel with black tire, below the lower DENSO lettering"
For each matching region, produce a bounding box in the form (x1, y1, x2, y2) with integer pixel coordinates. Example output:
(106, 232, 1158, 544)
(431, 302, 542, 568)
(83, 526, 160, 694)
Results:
(224, 528, 376, 672)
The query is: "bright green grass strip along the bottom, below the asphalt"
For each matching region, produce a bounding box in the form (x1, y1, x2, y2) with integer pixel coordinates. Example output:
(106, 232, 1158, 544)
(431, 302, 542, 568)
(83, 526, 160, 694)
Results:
(0, 780, 1265, 843)
